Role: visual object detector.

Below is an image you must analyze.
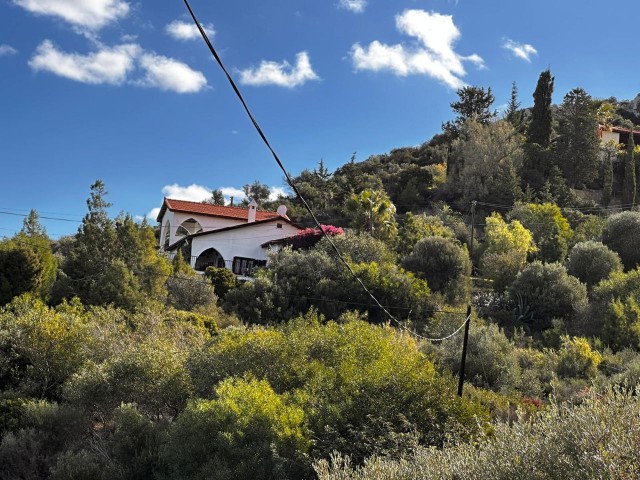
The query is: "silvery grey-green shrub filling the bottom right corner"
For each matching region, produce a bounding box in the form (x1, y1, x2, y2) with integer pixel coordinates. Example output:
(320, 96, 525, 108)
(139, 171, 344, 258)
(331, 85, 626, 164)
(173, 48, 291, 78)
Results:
(314, 389, 640, 480)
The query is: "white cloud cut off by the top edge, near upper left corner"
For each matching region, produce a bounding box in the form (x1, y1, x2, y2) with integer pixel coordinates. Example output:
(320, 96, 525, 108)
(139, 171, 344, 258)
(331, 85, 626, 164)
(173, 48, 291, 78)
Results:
(13, 0, 130, 30)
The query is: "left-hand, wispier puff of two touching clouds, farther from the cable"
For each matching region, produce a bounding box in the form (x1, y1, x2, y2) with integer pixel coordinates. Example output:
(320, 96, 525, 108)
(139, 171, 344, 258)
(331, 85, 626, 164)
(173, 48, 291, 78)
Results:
(29, 40, 140, 85)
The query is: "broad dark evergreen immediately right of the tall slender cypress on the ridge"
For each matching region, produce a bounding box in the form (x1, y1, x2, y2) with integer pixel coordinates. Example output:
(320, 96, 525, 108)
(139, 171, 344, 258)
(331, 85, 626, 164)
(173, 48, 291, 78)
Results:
(555, 88, 600, 187)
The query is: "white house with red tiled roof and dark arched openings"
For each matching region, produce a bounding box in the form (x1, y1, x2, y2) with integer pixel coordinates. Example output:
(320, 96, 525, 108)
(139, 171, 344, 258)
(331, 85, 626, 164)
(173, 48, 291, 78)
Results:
(157, 198, 300, 277)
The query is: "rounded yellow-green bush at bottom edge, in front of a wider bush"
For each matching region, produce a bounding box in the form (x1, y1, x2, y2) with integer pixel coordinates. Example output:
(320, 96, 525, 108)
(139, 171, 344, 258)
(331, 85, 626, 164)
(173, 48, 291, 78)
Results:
(162, 377, 311, 480)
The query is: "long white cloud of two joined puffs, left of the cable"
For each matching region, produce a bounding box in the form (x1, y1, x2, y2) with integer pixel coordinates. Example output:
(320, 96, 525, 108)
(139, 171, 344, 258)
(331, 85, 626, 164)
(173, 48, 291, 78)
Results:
(29, 40, 207, 93)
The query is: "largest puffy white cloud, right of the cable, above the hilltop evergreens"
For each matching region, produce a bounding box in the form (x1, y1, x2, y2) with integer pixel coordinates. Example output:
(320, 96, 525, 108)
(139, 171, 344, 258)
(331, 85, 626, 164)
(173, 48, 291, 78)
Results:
(351, 10, 485, 88)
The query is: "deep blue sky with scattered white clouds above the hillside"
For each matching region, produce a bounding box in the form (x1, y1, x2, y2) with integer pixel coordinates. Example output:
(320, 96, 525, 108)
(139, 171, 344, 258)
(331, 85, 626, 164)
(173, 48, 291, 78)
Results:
(0, 0, 640, 238)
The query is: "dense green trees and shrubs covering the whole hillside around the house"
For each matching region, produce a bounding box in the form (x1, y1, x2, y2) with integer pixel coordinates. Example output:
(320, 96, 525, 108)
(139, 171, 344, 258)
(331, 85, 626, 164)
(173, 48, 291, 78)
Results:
(0, 71, 640, 480)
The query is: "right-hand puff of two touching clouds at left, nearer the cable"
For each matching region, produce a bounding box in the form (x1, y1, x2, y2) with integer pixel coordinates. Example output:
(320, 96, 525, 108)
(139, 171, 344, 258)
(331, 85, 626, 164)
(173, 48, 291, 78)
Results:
(138, 53, 207, 93)
